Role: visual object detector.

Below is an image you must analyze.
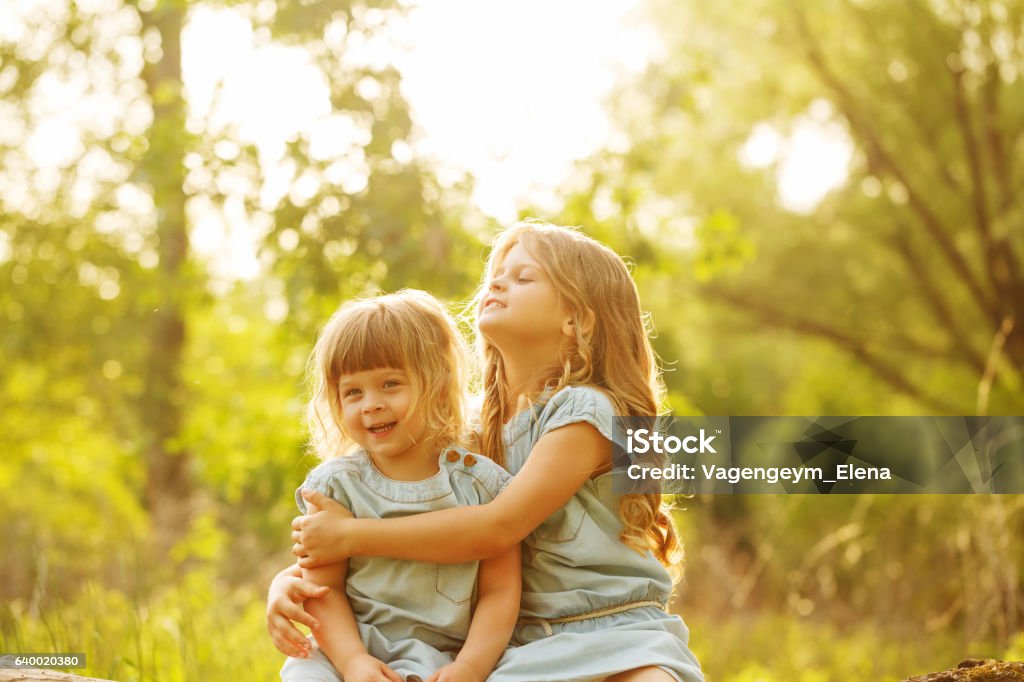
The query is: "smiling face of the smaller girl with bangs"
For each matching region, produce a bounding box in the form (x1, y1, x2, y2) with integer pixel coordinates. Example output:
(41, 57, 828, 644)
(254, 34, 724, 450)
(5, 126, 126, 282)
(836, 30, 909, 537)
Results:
(338, 368, 436, 473)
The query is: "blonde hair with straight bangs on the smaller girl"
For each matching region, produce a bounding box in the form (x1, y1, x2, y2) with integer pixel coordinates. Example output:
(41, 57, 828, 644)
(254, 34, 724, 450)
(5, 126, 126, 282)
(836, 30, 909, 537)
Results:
(306, 289, 468, 460)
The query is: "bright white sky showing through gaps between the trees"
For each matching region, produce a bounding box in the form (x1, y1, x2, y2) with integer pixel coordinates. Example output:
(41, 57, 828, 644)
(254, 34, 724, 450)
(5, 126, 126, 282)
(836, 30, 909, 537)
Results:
(0, 0, 856, 279)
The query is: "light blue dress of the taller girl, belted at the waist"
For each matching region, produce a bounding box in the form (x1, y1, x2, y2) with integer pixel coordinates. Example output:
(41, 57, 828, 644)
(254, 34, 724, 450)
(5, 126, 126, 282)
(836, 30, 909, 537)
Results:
(487, 386, 703, 682)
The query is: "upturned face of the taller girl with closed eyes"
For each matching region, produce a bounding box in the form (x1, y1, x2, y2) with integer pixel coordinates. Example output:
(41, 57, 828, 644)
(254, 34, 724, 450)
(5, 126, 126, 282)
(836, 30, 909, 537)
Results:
(477, 242, 572, 348)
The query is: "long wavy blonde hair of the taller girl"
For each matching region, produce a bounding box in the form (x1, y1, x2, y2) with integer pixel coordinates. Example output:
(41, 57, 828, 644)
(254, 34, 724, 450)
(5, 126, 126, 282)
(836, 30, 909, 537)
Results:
(473, 221, 682, 579)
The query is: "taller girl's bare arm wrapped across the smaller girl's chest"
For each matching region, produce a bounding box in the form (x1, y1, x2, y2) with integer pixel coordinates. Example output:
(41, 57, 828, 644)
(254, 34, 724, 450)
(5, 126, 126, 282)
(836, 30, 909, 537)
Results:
(292, 422, 611, 567)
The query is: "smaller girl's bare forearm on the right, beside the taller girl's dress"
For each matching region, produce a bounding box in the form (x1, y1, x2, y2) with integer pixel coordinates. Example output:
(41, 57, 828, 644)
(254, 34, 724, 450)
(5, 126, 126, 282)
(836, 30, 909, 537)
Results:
(427, 545, 522, 682)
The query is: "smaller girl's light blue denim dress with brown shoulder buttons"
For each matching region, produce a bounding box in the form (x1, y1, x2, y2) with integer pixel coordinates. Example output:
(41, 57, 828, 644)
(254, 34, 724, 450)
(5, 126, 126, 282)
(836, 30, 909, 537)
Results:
(281, 446, 510, 682)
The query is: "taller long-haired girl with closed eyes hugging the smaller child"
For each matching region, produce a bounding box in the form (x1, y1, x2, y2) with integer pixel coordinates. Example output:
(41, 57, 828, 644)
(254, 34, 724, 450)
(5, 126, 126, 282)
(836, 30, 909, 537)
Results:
(271, 223, 702, 682)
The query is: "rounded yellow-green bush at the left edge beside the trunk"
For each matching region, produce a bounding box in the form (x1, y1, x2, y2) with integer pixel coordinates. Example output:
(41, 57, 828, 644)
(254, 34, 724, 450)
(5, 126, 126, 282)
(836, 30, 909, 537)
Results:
(0, 356, 146, 599)
